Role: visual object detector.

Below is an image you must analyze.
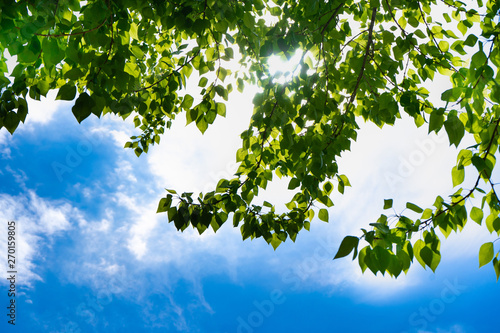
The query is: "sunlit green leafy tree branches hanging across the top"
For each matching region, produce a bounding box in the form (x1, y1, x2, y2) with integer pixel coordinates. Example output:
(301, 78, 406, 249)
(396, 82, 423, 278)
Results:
(0, 0, 500, 279)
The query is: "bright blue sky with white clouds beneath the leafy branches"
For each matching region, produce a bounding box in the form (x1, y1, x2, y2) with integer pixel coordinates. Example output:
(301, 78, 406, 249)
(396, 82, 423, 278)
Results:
(0, 55, 500, 333)
